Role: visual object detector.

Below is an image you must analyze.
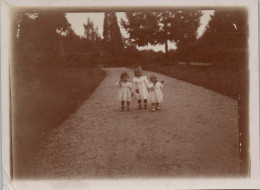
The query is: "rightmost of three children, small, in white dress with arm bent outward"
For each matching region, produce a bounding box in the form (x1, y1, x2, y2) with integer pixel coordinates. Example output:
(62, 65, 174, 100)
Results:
(149, 75, 163, 112)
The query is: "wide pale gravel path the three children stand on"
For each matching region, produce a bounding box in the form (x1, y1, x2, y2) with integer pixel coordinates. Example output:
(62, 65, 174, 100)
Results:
(29, 68, 239, 178)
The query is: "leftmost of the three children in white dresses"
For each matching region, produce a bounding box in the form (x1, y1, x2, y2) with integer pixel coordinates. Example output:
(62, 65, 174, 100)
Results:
(116, 72, 134, 111)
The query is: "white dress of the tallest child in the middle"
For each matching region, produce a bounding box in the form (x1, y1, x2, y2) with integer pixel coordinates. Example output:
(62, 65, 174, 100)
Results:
(133, 76, 149, 100)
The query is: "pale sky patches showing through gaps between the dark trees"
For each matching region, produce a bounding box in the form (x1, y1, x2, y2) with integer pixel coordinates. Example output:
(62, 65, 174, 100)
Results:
(66, 10, 214, 52)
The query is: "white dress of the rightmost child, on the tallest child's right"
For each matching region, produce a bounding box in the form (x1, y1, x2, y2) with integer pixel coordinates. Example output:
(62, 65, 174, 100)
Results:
(149, 82, 163, 104)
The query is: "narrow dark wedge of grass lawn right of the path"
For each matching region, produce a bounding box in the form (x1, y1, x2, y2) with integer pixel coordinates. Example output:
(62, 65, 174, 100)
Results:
(144, 65, 248, 99)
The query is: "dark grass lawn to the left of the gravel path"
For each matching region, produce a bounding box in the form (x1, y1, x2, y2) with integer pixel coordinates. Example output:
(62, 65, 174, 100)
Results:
(11, 64, 105, 177)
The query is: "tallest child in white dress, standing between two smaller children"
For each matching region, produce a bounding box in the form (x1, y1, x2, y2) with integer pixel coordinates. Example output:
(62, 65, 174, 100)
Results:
(133, 67, 149, 109)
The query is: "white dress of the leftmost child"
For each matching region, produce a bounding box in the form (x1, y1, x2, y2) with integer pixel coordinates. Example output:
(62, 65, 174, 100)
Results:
(116, 82, 133, 102)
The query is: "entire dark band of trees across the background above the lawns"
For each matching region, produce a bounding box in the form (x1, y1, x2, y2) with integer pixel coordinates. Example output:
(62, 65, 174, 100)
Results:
(12, 9, 248, 66)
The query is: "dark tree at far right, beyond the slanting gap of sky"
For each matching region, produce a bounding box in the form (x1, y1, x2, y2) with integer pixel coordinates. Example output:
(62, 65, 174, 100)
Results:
(199, 9, 248, 65)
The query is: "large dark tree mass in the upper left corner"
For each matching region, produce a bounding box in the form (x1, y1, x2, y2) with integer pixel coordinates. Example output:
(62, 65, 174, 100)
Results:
(11, 12, 70, 62)
